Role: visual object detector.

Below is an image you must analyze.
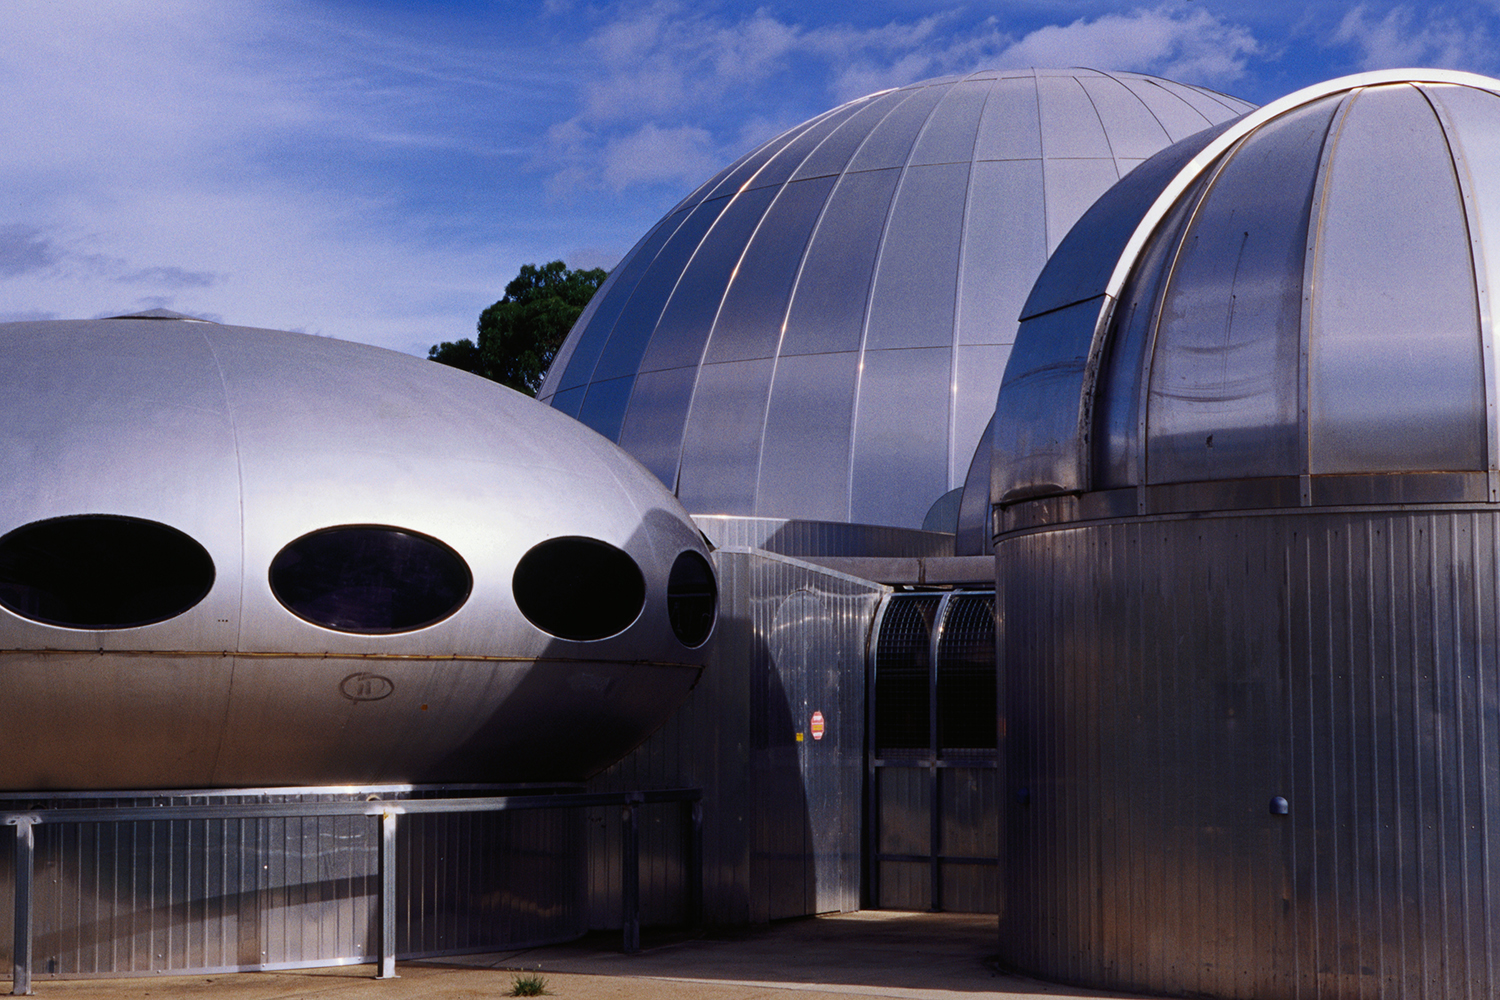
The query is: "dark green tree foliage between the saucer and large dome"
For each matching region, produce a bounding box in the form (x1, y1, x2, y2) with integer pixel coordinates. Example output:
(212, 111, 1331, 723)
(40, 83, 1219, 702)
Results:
(428, 261, 606, 396)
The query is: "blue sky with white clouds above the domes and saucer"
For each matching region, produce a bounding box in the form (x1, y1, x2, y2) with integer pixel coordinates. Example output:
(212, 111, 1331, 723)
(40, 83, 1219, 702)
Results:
(0, 0, 1500, 354)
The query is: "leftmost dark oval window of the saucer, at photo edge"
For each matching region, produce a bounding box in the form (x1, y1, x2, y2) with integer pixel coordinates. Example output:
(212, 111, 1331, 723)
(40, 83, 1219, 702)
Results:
(0, 514, 213, 628)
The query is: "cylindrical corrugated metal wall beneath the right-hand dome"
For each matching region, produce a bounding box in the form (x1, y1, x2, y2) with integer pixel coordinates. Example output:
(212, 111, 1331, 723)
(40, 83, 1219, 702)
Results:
(998, 510, 1500, 1000)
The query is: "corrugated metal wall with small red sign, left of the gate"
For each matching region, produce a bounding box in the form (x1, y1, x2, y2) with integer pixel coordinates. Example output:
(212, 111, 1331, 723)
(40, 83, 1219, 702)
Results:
(590, 542, 888, 928)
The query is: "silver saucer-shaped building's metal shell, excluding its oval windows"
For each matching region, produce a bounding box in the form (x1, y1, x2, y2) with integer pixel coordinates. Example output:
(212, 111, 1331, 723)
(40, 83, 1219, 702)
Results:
(0, 318, 710, 789)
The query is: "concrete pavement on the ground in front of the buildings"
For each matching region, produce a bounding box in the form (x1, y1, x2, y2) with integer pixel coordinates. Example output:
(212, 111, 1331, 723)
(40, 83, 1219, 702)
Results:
(14, 910, 1133, 1000)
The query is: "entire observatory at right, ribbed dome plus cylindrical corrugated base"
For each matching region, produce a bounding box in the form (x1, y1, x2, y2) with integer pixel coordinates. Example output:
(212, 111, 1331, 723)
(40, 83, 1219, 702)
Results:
(993, 70, 1500, 1000)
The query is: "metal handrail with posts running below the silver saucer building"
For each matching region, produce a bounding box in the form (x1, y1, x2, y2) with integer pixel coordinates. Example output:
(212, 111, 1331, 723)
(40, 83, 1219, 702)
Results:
(0, 789, 704, 997)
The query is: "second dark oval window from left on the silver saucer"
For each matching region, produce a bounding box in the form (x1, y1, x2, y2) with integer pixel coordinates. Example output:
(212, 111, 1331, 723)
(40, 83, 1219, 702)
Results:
(270, 525, 474, 634)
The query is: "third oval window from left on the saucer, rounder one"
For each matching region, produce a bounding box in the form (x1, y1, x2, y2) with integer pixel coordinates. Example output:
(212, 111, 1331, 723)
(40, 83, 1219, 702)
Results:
(512, 537, 647, 642)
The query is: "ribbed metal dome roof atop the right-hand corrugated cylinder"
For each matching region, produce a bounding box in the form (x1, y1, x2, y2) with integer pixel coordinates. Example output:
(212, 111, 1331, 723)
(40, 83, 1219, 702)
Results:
(993, 70, 1500, 513)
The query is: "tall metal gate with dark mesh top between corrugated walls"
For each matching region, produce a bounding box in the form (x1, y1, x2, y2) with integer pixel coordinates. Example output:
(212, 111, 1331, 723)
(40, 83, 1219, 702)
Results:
(866, 591, 1001, 913)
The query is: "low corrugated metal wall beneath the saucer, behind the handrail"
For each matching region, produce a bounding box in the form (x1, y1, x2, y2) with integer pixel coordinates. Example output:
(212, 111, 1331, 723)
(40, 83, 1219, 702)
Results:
(0, 790, 587, 978)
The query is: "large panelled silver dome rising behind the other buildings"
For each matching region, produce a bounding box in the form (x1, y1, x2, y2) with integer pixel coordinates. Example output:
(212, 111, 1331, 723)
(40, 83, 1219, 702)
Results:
(540, 69, 1251, 528)
